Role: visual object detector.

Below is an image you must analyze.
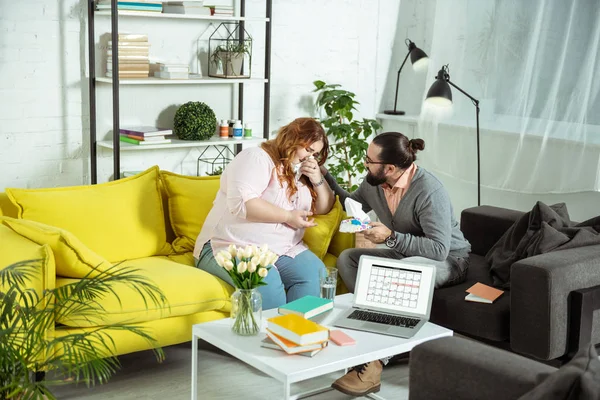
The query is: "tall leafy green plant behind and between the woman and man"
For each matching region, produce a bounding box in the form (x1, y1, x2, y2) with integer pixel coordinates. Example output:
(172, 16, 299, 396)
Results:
(313, 81, 381, 191)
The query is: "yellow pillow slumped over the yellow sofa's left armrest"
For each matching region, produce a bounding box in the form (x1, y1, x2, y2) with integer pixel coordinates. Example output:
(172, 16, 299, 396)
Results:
(0, 217, 112, 278)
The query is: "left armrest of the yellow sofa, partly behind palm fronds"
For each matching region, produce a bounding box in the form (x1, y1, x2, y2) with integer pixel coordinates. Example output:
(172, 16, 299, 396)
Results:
(0, 225, 56, 296)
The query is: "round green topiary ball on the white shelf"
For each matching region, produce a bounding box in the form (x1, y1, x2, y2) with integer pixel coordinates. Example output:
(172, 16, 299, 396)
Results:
(173, 101, 217, 140)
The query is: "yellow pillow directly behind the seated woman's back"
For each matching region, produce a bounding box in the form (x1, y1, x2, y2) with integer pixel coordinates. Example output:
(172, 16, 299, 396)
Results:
(160, 171, 221, 253)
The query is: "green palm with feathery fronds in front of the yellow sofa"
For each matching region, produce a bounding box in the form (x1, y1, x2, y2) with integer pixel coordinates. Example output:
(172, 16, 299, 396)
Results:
(0, 260, 168, 400)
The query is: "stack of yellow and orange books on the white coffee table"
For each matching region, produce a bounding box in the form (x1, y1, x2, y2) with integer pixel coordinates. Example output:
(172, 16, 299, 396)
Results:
(262, 314, 329, 357)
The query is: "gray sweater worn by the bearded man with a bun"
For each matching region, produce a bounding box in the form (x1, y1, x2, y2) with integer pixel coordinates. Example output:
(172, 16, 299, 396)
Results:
(325, 167, 471, 261)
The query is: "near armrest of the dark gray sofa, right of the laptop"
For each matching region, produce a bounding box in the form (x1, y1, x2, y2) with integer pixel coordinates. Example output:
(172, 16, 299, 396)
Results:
(510, 245, 600, 360)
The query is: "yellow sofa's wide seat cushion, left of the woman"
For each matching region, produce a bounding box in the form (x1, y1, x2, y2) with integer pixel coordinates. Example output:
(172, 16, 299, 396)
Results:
(56, 257, 232, 327)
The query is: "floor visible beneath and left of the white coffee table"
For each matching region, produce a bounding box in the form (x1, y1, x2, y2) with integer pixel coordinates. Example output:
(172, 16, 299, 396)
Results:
(53, 341, 408, 400)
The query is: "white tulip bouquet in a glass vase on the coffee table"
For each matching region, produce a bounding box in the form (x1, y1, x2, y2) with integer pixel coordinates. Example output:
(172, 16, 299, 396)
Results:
(215, 244, 278, 336)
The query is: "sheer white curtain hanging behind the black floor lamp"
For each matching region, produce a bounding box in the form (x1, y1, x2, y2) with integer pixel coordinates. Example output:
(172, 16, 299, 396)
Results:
(419, 0, 600, 193)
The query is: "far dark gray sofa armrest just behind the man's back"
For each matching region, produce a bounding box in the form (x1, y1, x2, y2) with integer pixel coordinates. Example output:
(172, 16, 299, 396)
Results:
(460, 206, 523, 256)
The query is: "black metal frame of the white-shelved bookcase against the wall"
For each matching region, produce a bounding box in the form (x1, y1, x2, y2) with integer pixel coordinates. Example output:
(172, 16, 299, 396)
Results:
(87, 0, 273, 184)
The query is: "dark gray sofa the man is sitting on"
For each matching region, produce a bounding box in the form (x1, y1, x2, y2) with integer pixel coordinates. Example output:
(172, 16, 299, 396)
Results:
(431, 206, 600, 360)
